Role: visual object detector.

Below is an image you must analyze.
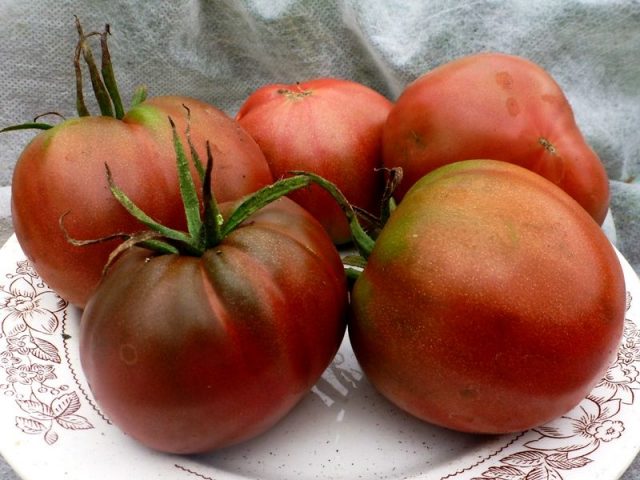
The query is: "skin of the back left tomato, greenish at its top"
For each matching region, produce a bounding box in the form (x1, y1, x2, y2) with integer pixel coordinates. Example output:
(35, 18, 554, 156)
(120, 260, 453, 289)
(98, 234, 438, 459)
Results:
(11, 96, 271, 307)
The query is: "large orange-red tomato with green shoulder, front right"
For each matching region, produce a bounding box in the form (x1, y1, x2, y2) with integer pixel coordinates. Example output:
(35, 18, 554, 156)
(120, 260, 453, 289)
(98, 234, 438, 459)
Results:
(349, 160, 626, 433)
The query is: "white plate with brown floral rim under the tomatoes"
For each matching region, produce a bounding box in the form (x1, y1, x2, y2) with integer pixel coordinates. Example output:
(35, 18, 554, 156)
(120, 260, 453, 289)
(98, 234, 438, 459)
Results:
(0, 237, 640, 480)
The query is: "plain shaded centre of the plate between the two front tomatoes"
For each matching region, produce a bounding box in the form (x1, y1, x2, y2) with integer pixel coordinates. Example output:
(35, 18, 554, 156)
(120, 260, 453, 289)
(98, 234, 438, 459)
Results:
(176, 337, 518, 480)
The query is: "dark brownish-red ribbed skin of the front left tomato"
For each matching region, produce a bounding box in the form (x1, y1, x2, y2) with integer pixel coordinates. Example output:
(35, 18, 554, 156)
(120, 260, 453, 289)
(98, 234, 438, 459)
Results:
(80, 198, 347, 453)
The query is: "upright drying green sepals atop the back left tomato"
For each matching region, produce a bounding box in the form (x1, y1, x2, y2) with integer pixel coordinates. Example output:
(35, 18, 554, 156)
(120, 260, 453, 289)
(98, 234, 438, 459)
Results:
(0, 17, 147, 133)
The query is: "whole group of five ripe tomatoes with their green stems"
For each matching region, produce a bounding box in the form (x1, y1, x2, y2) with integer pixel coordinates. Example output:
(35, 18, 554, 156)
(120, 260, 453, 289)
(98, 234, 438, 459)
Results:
(5, 24, 625, 453)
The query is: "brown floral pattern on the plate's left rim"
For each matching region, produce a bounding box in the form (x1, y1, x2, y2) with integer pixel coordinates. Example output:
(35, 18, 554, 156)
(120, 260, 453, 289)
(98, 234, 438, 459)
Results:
(0, 260, 93, 445)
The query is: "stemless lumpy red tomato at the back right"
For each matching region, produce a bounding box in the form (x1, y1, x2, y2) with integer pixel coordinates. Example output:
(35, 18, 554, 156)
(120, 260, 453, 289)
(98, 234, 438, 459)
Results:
(383, 53, 609, 224)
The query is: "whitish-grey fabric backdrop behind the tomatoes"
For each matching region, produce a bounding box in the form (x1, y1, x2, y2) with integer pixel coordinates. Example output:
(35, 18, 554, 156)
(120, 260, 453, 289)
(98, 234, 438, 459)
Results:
(0, 0, 640, 480)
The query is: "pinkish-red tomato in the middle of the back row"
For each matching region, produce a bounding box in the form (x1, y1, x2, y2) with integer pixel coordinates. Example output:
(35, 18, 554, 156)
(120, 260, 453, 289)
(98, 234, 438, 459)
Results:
(236, 78, 392, 243)
